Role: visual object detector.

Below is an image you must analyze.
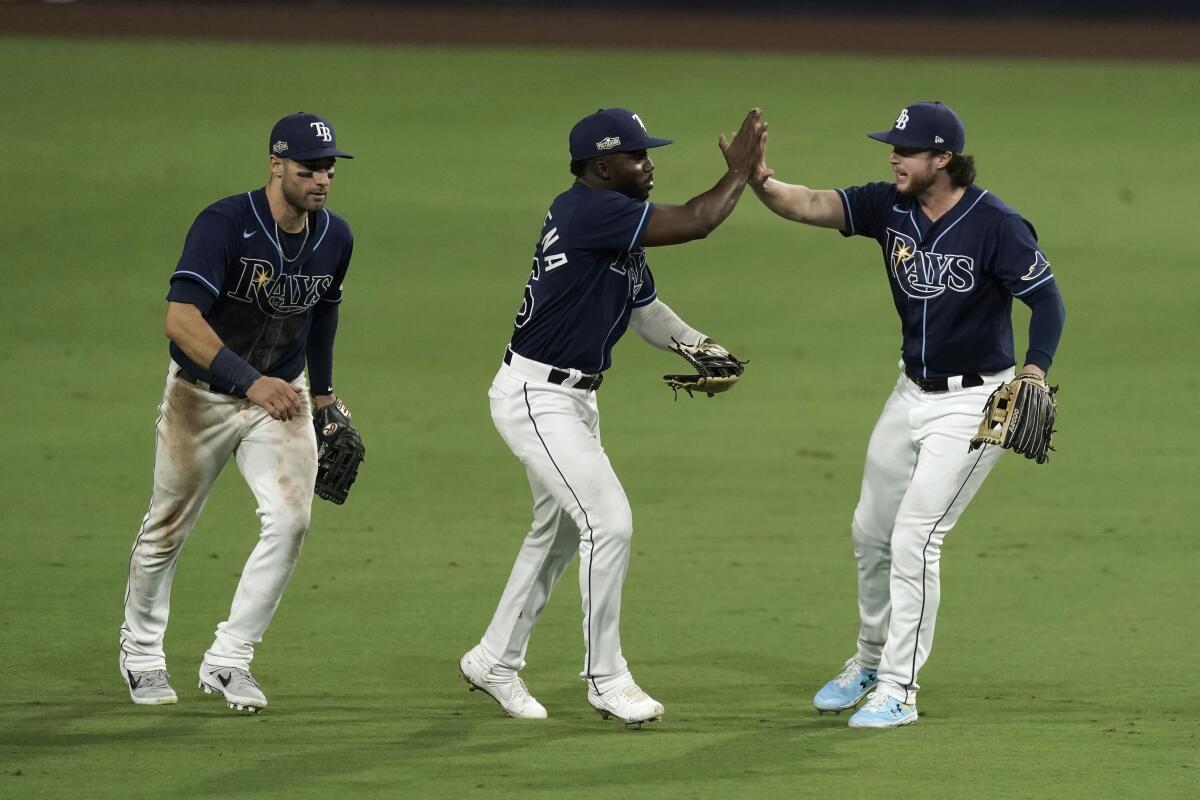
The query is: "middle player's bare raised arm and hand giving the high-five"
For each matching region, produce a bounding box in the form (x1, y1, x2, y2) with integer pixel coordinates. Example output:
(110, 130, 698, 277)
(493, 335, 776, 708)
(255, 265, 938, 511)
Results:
(642, 108, 767, 247)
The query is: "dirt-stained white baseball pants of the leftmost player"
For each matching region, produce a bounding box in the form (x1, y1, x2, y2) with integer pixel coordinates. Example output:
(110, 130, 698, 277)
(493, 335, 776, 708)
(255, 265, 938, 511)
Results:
(121, 363, 317, 670)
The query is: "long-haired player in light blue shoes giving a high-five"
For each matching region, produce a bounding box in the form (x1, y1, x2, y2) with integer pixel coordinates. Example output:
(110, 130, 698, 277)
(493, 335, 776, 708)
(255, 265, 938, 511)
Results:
(752, 102, 1066, 728)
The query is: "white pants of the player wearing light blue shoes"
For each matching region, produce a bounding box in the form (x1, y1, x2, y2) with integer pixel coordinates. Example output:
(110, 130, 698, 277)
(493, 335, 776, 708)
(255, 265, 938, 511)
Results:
(851, 369, 1013, 703)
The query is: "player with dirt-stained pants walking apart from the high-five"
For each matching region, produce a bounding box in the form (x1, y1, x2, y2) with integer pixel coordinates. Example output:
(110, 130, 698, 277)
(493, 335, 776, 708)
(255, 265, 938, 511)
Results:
(120, 112, 353, 711)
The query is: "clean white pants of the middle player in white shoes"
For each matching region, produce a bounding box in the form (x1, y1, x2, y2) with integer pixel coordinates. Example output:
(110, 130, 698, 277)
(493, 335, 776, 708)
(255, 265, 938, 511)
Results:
(481, 354, 634, 692)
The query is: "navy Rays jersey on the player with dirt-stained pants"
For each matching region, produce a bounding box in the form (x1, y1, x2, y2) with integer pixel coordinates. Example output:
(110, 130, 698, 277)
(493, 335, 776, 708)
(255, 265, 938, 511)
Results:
(167, 190, 354, 393)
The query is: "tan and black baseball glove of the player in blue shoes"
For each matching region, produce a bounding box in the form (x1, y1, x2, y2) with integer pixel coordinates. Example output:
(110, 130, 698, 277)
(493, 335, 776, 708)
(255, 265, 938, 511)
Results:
(971, 373, 1058, 464)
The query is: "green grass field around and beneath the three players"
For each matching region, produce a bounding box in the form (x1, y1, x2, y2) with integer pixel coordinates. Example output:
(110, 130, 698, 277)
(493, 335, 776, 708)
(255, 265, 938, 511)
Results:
(0, 38, 1200, 798)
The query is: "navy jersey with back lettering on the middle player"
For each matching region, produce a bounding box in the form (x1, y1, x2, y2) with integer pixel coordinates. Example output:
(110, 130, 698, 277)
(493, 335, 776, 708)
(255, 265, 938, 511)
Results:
(511, 182, 655, 373)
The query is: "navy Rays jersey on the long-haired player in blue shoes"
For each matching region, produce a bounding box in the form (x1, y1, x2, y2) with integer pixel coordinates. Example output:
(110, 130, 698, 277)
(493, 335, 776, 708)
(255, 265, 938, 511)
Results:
(838, 182, 1054, 378)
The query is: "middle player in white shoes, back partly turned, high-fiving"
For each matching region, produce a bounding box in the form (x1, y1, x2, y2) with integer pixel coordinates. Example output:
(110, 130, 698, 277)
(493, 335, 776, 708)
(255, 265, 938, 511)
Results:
(458, 108, 767, 724)
